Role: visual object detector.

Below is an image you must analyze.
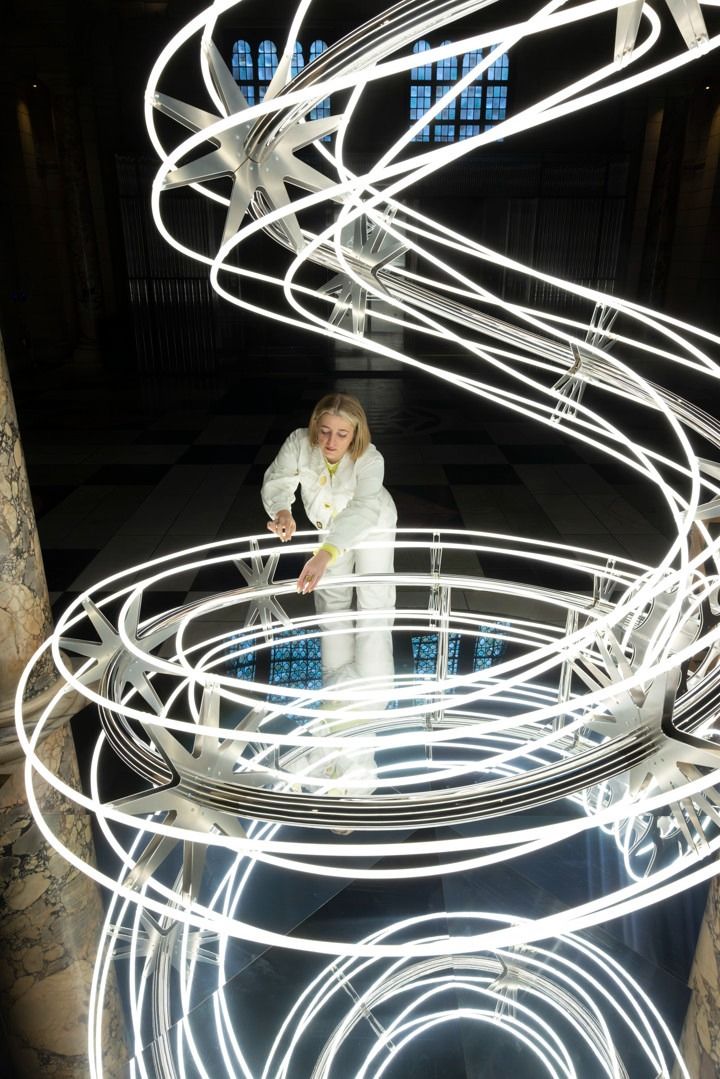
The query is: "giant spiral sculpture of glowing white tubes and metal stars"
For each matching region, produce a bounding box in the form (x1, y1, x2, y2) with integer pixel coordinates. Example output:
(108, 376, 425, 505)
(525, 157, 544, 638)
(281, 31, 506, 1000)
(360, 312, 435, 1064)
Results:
(17, 0, 720, 1077)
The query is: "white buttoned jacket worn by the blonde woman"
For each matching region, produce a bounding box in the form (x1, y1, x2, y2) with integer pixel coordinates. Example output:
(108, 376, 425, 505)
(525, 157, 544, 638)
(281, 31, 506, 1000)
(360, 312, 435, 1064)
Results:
(261, 427, 397, 552)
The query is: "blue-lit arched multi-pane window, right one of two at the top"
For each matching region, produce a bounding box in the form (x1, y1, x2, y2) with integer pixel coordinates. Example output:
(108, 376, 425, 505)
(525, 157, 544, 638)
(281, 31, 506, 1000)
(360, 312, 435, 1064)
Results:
(410, 41, 510, 142)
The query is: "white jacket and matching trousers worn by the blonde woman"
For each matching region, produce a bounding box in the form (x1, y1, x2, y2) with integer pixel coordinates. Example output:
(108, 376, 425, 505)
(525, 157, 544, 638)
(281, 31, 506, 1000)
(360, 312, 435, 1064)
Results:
(261, 427, 397, 685)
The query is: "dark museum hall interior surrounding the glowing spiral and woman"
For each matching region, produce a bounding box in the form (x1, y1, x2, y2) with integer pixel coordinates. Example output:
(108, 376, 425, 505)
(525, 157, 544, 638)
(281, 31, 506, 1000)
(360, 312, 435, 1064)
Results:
(0, 0, 720, 1079)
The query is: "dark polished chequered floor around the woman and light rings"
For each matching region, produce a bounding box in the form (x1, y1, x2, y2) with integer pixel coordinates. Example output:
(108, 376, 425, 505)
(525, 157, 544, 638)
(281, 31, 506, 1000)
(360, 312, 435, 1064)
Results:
(14, 342, 704, 1079)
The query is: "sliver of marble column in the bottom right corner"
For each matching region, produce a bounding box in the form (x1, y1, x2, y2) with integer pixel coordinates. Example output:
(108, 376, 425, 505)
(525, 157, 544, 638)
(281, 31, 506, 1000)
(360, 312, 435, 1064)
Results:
(674, 876, 720, 1079)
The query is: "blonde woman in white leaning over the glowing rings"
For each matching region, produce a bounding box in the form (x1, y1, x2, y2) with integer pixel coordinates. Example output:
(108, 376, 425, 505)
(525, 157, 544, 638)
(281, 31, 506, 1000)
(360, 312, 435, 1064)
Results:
(262, 394, 397, 685)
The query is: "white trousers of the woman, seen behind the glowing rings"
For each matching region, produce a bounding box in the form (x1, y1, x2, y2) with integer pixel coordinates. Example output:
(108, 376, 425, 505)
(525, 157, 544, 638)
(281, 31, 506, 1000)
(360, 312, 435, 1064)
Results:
(313, 532, 395, 685)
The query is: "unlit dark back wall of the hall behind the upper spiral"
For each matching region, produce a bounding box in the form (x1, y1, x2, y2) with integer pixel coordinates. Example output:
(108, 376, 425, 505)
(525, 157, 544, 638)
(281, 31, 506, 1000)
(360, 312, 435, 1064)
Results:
(0, 0, 720, 372)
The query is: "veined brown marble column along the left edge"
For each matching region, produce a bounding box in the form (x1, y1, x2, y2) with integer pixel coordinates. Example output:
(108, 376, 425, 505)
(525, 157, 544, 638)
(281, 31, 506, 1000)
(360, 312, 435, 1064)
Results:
(0, 340, 126, 1079)
